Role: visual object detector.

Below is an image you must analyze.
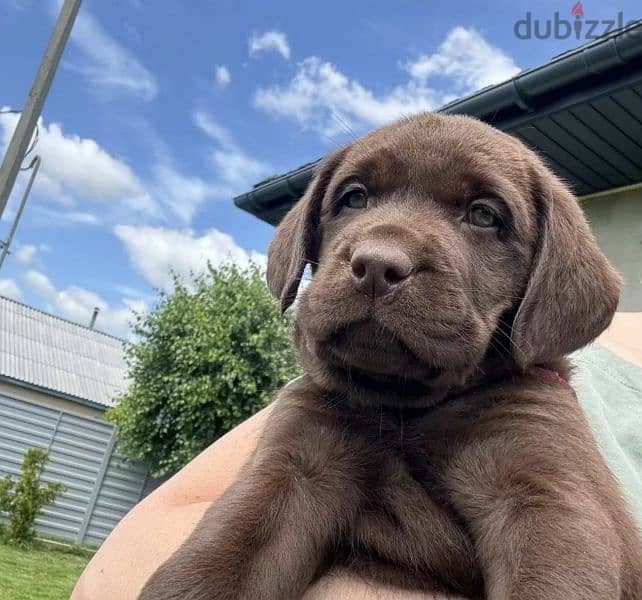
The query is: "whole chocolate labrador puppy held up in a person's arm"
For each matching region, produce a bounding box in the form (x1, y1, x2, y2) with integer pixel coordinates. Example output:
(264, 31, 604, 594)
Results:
(141, 114, 642, 600)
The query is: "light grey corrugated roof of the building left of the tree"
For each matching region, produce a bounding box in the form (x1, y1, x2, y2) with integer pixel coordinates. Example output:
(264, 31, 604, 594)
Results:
(0, 296, 126, 408)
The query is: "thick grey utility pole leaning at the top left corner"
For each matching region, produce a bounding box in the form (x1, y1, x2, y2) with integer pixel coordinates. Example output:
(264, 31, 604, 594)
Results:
(0, 0, 82, 219)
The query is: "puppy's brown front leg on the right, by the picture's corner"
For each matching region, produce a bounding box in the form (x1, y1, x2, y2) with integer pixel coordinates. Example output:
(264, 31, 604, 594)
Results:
(450, 439, 628, 600)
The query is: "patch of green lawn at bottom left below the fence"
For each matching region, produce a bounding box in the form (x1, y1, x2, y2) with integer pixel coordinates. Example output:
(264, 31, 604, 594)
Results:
(0, 542, 90, 600)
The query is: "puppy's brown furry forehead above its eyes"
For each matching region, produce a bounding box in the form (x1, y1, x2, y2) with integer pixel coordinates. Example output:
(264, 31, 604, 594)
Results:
(324, 115, 528, 209)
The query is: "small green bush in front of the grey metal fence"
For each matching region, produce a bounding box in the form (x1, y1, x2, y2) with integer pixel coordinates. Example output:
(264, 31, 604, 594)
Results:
(0, 448, 65, 544)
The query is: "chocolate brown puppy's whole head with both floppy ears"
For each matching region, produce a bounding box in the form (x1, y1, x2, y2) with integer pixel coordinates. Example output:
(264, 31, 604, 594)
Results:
(267, 114, 620, 406)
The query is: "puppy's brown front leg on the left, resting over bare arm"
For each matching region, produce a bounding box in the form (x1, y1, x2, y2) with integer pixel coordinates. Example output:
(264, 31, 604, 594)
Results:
(140, 393, 365, 600)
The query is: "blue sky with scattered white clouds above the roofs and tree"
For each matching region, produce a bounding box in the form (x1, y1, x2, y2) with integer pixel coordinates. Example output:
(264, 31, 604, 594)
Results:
(0, 0, 642, 336)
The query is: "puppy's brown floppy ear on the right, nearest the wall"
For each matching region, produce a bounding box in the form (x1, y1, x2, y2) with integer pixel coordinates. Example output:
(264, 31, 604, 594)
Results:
(511, 166, 622, 368)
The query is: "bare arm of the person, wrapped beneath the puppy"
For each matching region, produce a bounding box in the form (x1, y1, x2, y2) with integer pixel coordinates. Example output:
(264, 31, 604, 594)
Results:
(71, 408, 450, 600)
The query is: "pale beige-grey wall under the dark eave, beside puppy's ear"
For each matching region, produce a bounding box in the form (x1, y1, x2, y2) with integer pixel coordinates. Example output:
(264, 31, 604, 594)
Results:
(582, 187, 642, 312)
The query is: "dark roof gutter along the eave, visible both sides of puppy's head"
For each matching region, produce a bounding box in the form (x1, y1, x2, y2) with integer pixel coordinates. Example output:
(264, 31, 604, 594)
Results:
(234, 21, 642, 225)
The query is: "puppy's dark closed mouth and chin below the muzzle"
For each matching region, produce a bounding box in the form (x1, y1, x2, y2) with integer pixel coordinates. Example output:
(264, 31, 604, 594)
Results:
(317, 320, 443, 396)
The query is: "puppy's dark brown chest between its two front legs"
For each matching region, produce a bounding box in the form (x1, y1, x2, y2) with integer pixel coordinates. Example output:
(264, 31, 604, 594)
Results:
(340, 420, 483, 598)
